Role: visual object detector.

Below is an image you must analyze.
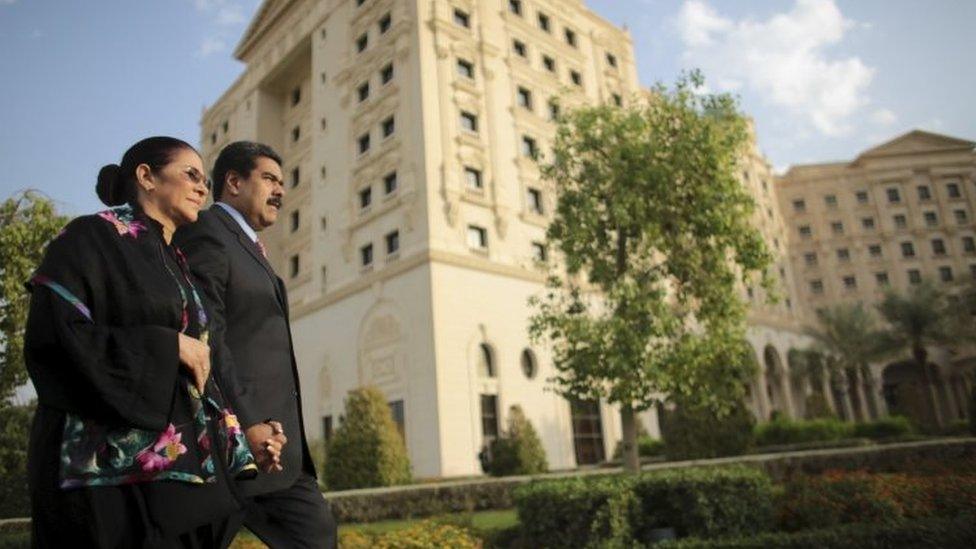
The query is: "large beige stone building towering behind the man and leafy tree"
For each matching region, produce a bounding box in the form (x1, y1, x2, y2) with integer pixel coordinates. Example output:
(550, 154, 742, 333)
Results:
(201, 0, 968, 477)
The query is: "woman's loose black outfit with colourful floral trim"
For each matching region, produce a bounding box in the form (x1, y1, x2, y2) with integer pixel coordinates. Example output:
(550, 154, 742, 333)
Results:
(25, 205, 257, 547)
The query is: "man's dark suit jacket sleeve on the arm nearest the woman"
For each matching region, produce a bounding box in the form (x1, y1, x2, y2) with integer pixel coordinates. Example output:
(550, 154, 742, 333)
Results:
(177, 218, 264, 429)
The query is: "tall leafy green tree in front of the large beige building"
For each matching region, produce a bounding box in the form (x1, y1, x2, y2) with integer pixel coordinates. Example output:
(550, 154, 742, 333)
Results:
(529, 73, 772, 471)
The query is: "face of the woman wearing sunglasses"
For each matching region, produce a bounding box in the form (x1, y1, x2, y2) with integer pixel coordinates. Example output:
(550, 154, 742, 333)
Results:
(149, 149, 210, 227)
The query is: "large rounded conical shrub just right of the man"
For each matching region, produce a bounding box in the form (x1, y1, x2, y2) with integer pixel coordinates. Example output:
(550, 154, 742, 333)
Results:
(323, 387, 411, 490)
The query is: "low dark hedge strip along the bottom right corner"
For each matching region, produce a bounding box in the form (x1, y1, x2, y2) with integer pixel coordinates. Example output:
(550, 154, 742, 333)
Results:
(655, 513, 976, 549)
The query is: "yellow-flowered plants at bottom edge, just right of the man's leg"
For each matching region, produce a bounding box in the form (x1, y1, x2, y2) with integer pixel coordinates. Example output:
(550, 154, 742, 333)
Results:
(339, 520, 481, 549)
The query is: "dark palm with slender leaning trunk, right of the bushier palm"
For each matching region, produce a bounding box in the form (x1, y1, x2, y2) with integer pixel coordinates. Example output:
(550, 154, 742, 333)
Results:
(878, 282, 958, 427)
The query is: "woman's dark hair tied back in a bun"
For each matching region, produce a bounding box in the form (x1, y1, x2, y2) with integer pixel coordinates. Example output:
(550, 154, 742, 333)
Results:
(95, 136, 196, 206)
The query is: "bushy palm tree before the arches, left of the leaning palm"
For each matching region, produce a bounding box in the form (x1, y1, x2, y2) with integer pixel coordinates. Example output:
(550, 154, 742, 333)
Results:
(810, 303, 888, 421)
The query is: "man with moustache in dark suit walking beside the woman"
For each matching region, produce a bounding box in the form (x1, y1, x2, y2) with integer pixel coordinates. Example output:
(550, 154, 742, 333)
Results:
(174, 141, 336, 547)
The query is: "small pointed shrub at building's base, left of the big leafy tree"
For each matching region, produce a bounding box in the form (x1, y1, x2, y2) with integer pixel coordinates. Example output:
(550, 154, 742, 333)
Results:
(487, 405, 549, 477)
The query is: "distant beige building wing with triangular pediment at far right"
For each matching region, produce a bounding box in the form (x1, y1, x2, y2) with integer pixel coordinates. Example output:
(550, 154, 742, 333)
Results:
(777, 130, 976, 428)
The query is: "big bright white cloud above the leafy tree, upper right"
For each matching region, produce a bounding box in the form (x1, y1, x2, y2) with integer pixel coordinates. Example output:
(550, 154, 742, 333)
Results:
(675, 0, 875, 135)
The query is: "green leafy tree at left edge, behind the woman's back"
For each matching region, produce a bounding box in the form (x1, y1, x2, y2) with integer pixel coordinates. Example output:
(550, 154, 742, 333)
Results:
(0, 190, 68, 403)
